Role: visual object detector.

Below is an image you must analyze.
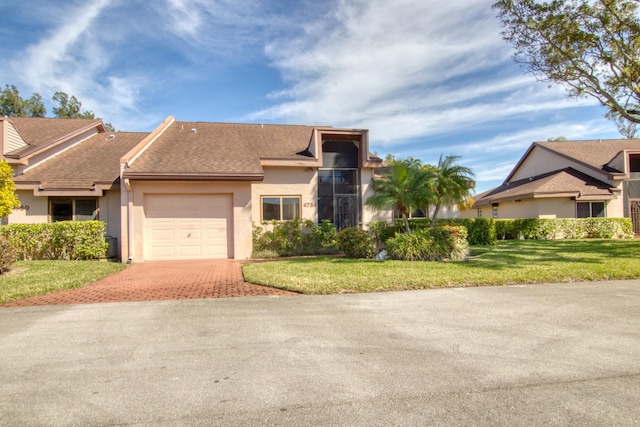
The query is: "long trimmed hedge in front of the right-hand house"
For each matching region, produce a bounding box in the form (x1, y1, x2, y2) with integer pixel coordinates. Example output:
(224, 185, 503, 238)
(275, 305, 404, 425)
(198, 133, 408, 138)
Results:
(495, 218, 633, 240)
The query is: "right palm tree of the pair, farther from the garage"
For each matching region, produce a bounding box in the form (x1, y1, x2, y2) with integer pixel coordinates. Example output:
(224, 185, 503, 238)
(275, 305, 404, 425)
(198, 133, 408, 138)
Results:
(427, 155, 474, 227)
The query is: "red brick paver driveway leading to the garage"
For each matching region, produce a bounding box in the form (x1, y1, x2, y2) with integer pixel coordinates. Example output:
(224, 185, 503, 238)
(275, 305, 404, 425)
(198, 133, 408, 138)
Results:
(0, 259, 297, 307)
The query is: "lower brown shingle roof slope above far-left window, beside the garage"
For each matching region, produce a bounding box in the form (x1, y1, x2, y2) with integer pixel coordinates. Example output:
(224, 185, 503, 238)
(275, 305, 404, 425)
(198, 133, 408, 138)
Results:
(14, 132, 147, 189)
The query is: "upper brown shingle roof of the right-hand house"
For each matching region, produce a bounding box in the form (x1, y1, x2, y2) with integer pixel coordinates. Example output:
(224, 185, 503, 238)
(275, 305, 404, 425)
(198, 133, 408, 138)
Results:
(534, 139, 640, 172)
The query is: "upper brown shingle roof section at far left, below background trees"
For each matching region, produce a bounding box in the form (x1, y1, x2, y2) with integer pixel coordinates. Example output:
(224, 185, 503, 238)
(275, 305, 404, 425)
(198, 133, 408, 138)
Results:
(7, 117, 102, 156)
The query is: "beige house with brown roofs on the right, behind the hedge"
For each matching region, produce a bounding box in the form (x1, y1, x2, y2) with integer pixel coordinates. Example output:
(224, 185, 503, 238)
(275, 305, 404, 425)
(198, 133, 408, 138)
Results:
(461, 139, 640, 234)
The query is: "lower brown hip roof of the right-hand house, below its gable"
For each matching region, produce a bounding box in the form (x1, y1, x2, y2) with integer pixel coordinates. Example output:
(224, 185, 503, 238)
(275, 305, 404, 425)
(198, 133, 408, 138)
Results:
(473, 168, 614, 208)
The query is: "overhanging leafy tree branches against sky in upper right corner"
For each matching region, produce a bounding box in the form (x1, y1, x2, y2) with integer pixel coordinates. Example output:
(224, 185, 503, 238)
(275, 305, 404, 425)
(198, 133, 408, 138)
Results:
(493, 0, 640, 128)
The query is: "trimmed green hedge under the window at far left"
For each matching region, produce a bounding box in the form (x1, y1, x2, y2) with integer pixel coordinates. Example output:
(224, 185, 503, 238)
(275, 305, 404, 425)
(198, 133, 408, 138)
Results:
(0, 221, 108, 260)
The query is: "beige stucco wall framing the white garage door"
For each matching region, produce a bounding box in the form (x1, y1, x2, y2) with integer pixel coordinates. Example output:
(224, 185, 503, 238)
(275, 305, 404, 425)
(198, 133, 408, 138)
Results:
(120, 181, 252, 262)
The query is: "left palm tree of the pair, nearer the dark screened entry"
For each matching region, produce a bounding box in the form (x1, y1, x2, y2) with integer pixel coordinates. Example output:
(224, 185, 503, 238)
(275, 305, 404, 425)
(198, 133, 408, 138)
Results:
(366, 159, 432, 233)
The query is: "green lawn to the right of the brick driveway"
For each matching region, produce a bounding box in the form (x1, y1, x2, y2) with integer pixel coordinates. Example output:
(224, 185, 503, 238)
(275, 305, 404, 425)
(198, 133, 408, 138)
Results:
(243, 239, 640, 294)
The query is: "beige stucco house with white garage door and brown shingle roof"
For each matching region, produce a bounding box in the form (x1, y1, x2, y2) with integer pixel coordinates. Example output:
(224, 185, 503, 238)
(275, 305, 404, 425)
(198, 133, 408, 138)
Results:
(0, 117, 384, 262)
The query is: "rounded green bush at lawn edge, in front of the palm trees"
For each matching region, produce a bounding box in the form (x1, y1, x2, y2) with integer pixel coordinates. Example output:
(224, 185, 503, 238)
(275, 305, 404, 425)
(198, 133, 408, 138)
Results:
(387, 226, 469, 261)
